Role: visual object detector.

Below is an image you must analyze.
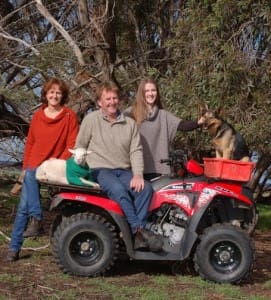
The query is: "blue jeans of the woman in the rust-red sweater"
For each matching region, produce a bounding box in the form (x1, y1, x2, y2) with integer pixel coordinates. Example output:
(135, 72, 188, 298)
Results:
(9, 169, 42, 251)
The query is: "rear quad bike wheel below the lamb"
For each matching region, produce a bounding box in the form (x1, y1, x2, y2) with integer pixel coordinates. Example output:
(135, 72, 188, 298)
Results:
(51, 213, 118, 276)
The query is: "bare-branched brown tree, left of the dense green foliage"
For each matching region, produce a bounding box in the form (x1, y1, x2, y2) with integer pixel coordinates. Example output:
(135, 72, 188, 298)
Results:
(0, 0, 181, 134)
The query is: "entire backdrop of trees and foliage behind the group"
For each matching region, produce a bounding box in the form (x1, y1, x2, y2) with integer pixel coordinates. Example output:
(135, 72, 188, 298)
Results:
(0, 0, 271, 161)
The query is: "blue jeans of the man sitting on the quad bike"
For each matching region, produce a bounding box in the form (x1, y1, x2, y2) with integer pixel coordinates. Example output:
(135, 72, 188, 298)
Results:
(92, 168, 153, 233)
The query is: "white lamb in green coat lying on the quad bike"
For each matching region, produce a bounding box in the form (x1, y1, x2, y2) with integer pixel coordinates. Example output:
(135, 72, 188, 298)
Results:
(36, 148, 99, 187)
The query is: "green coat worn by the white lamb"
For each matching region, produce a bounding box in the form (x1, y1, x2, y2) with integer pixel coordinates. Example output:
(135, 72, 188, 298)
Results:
(66, 157, 93, 185)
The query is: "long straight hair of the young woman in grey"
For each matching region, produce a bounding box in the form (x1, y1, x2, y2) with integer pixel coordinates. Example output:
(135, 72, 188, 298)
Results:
(131, 78, 163, 124)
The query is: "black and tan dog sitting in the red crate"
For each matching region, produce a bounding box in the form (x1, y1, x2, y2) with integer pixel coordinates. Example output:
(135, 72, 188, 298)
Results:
(200, 105, 249, 161)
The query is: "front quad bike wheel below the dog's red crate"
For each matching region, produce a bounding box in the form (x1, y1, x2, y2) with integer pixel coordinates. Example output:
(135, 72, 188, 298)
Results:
(194, 224, 254, 283)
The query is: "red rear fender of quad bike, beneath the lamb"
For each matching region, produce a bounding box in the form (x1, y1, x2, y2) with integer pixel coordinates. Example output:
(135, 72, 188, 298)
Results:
(50, 192, 124, 216)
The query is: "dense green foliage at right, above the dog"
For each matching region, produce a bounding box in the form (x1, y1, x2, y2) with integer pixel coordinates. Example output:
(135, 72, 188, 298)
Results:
(161, 0, 271, 151)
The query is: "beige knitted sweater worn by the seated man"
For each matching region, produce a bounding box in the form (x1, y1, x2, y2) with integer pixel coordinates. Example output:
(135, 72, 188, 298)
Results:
(76, 110, 143, 175)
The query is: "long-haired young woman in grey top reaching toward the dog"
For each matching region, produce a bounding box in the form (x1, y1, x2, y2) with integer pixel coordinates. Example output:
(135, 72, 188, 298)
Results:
(125, 78, 203, 180)
